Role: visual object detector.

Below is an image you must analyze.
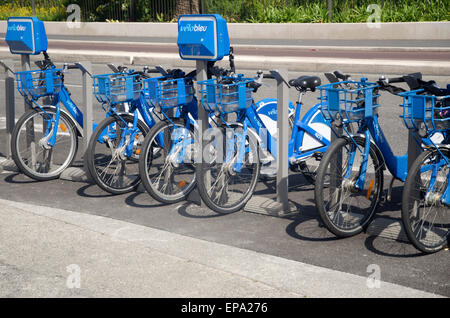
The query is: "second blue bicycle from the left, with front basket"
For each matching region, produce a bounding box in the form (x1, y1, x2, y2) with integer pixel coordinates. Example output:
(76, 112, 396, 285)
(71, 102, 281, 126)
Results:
(87, 66, 191, 194)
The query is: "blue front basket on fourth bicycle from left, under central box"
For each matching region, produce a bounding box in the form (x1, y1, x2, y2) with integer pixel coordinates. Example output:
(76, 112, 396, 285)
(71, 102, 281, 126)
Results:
(198, 76, 254, 114)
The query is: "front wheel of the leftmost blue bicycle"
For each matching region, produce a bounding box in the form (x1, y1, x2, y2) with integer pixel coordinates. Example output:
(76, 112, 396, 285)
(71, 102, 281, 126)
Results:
(11, 108, 78, 181)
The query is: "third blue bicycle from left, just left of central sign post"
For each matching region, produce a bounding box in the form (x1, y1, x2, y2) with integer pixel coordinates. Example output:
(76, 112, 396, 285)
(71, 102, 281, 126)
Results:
(139, 71, 198, 203)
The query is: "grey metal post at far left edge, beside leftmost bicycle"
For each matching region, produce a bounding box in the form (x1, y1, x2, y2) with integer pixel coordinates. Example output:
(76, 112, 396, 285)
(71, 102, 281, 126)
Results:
(0, 60, 15, 159)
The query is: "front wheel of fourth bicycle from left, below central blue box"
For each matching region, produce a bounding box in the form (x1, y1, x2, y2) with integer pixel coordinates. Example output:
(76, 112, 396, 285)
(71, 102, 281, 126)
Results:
(196, 125, 260, 213)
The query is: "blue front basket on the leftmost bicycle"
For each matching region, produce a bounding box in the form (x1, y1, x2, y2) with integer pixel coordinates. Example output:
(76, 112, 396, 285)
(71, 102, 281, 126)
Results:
(16, 68, 62, 99)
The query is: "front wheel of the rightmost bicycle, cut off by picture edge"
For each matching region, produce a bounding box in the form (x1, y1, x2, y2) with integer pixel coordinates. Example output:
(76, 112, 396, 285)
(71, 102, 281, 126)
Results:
(402, 148, 450, 253)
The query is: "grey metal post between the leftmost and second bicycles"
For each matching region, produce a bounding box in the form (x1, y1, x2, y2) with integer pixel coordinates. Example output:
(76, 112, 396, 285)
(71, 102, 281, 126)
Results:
(75, 61, 94, 153)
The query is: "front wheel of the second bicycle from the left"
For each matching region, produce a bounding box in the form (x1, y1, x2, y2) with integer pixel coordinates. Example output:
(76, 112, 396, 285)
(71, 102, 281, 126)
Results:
(87, 115, 148, 194)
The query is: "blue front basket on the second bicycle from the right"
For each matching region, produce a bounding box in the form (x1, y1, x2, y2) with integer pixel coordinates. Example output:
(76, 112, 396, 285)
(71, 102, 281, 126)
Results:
(318, 78, 380, 123)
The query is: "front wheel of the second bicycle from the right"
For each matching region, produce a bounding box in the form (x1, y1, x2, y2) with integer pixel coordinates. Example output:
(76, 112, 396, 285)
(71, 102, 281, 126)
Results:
(314, 137, 383, 237)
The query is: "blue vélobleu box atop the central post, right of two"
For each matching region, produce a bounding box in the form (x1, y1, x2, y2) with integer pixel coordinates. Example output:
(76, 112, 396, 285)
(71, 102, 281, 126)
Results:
(177, 14, 230, 61)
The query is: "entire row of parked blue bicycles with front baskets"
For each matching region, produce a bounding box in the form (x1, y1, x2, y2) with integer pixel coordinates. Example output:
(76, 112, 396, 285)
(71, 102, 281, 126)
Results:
(11, 51, 450, 253)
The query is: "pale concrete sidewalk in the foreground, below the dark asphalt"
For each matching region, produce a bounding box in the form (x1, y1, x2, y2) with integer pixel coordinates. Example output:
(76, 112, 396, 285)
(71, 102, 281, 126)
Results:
(0, 200, 437, 297)
